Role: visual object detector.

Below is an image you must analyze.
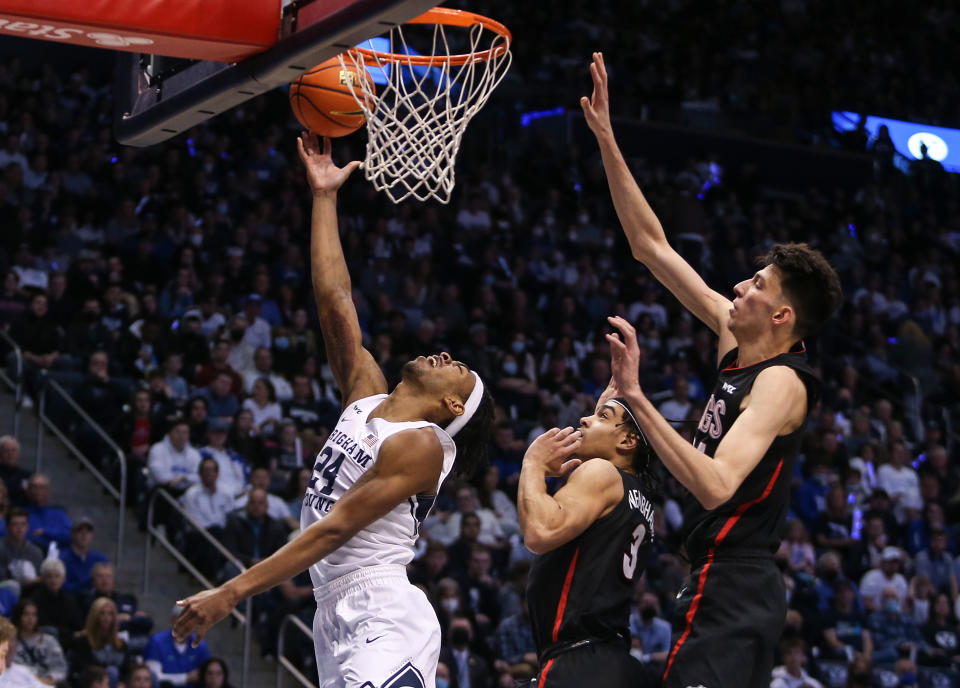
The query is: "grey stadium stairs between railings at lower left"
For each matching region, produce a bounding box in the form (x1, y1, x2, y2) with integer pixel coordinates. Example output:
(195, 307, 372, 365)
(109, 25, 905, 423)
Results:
(0, 385, 280, 688)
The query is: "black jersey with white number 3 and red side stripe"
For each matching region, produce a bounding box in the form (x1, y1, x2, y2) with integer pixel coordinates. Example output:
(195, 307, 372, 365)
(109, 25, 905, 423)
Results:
(527, 459, 653, 658)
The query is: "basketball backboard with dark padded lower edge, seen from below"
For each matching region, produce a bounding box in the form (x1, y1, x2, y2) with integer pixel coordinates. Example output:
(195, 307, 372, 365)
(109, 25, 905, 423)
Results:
(114, 0, 438, 146)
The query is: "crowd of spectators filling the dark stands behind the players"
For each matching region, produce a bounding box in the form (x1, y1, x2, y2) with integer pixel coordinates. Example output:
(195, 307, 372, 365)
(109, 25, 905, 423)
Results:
(0, 1, 960, 688)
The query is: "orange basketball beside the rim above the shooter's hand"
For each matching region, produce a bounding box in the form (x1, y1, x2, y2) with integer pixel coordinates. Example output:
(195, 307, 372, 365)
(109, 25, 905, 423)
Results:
(290, 57, 376, 138)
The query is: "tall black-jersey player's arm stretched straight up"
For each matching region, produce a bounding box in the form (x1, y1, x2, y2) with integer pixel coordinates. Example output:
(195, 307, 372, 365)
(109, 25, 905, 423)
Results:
(580, 53, 735, 354)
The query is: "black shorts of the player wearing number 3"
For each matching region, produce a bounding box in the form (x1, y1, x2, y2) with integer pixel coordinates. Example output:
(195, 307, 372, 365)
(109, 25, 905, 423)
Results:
(533, 643, 641, 688)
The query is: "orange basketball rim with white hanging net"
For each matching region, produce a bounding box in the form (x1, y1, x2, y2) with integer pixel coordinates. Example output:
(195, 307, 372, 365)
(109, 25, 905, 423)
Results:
(340, 7, 512, 203)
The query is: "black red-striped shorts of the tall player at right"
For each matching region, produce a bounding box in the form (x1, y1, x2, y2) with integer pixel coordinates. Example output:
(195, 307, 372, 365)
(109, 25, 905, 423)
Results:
(663, 557, 787, 688)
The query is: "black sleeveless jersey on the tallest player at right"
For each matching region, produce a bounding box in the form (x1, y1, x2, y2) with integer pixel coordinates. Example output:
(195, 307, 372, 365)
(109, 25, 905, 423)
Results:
(683, 344, 820, 564)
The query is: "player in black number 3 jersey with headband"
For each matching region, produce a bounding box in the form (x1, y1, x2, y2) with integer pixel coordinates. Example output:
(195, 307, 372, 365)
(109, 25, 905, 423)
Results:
(517, 384, 653, 688)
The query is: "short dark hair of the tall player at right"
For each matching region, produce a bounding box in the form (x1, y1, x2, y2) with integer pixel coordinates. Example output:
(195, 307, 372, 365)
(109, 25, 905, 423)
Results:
(757, 243, 843, 339)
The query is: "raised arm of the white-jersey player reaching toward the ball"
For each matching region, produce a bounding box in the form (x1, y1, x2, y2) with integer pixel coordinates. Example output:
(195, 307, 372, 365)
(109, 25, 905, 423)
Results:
(297, 132, 387, 408)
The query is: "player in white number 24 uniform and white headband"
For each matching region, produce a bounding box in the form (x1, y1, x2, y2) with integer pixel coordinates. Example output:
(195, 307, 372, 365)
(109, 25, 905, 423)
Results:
(173, 133, 493, 688)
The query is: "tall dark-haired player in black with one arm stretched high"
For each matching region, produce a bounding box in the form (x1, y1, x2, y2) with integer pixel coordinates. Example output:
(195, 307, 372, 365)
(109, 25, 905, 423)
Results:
(581, 53, 841, 688)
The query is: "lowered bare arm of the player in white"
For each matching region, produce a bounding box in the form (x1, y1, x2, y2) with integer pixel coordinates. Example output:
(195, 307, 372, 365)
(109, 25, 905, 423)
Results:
(173, 428, 443, 646)
